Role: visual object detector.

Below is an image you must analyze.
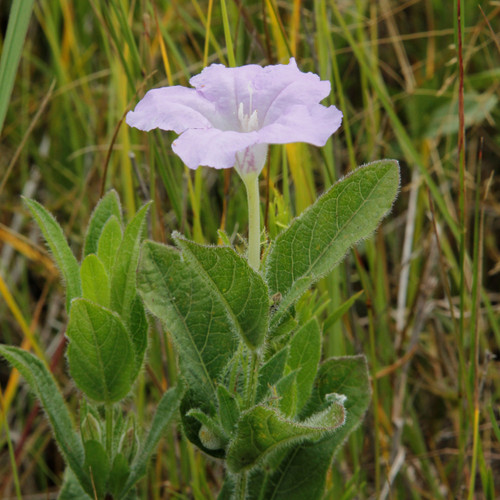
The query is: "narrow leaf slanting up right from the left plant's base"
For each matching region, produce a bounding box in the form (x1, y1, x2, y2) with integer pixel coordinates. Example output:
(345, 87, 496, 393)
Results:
(119, 384, 184, 498)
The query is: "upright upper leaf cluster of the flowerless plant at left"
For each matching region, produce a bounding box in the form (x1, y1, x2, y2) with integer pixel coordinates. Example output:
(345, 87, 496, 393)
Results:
(25, 191, 148, 403)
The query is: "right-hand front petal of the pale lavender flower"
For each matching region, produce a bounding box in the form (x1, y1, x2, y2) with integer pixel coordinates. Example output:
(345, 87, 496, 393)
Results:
(257, 104, 342, 146)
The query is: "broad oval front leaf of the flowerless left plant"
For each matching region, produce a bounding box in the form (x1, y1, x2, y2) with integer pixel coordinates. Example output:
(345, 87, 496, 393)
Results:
(67, 299, 135, 403)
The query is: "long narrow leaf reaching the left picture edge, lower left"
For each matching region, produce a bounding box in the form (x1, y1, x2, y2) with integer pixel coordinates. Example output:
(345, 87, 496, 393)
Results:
(0, 345, 92, 493)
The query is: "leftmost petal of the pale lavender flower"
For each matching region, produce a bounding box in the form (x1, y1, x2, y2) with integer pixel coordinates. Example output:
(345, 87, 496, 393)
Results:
(126, 86, 215, 134)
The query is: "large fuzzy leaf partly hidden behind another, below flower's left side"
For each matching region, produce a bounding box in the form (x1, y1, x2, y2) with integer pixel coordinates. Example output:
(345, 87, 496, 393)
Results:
(137, 241, 238, 401)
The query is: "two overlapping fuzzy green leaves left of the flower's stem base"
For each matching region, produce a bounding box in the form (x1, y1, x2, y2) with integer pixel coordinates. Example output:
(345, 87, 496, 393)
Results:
(137, 234, 269, 402)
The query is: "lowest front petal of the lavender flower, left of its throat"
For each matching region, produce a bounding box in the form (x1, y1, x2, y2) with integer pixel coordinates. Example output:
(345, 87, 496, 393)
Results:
(172, 128, 259, 169)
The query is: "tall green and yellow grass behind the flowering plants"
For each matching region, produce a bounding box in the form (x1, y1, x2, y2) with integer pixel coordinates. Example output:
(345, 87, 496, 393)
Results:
(0, 0, 500, 500)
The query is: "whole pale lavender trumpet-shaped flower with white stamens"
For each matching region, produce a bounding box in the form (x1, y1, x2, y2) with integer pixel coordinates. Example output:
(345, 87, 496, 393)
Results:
(126, 58, 342, 177)
